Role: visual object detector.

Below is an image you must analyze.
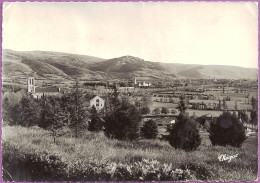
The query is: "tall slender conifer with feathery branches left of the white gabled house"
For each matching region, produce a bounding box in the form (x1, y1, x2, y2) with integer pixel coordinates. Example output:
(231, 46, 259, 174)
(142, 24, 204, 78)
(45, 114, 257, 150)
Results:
(68, 81, 87, 138)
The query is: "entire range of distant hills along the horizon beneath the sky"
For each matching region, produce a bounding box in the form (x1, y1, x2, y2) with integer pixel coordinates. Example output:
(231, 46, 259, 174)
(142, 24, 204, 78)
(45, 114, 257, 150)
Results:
(2, 50, 258, 81)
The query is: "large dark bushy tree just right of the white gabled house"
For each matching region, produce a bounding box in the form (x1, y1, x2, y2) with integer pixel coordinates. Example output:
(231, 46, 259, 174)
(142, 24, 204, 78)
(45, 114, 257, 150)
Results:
(104, 100, 142, 140)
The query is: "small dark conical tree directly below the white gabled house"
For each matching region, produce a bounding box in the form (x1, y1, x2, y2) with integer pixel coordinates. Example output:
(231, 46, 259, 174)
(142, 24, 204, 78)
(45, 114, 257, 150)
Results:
(88, 106, 103, 132)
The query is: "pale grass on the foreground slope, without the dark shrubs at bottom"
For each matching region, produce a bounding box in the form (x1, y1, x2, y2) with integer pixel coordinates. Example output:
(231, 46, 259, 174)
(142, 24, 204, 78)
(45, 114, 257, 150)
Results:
(2, 126, 258, 181)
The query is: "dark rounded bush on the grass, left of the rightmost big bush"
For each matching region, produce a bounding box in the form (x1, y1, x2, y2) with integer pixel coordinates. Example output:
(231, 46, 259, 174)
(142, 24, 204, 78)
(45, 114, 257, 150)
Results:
(168, 115, 201, 151)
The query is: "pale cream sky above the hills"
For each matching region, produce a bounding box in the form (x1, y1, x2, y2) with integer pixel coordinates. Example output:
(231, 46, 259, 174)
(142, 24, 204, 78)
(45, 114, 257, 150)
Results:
(2, 2, 258, 68)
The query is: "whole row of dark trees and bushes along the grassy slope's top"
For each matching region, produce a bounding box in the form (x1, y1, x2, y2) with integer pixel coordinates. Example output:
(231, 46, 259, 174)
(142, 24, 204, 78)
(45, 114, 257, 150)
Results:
(2, 83, 258, 151)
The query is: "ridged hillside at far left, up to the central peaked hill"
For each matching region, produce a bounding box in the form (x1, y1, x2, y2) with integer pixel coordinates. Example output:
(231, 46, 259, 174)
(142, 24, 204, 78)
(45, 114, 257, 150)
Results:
(2, 50, 104, 82)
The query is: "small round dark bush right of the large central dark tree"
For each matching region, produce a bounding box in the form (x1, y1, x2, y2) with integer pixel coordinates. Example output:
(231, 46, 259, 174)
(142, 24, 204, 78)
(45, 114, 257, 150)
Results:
(141, 120, 158, 139)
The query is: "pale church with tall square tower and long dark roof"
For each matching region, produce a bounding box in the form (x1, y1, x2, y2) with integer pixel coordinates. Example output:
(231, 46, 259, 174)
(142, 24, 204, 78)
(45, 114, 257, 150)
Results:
(27, 77, 60, 98)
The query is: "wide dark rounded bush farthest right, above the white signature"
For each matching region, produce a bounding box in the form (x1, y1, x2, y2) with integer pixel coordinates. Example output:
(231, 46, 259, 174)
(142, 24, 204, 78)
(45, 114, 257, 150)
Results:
(209, 112, 246, 147)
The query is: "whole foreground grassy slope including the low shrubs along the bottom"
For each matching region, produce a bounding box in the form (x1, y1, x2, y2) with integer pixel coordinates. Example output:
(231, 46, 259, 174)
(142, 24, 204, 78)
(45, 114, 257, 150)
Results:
(2, 126, 258, 182)
